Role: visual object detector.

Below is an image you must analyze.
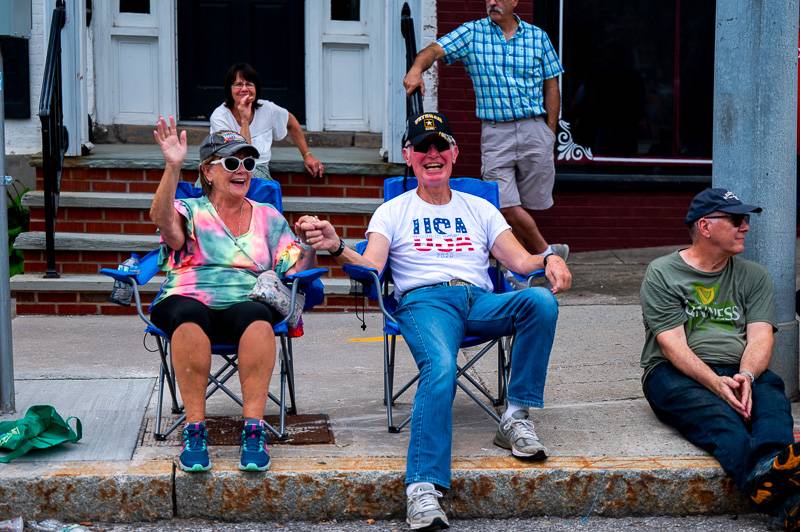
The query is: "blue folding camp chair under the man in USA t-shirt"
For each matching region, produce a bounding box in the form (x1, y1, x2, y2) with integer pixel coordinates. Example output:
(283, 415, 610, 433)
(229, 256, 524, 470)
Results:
(343, 177, 544, 433)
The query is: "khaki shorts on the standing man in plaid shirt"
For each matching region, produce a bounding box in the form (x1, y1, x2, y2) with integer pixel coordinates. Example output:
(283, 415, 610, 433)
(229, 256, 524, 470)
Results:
(481, 117, 556, 211)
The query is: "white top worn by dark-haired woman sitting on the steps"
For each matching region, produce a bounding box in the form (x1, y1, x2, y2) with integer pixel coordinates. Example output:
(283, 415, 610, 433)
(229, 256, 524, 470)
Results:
(210, 100, 289, 164)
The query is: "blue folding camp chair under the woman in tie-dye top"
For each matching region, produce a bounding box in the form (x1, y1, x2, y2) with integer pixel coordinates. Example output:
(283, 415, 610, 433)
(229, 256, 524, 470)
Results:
(100, 179, 328, 440)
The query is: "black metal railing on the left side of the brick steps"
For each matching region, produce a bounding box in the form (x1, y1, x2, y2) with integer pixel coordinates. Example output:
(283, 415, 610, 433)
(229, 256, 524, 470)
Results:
(39, 0, 69, 278)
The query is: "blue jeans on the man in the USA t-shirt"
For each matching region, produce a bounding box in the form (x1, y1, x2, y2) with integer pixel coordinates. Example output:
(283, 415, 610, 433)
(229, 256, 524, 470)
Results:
(395, 286, 558, 488)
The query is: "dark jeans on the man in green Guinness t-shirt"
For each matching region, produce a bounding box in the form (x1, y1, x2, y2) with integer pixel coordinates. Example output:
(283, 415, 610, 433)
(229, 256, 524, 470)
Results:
(644, 362, 794, 489)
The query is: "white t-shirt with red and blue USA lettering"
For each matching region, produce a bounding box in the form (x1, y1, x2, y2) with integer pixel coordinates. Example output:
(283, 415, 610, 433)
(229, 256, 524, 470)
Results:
(367, 190, 510, 299)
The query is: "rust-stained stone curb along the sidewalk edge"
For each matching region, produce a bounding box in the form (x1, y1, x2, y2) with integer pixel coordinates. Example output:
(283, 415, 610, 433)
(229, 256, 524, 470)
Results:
(0, 457, 749, 522)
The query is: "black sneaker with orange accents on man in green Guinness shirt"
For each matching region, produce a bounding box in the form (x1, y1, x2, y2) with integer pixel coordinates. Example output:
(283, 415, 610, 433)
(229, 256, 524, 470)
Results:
(747, 443, 800, 509)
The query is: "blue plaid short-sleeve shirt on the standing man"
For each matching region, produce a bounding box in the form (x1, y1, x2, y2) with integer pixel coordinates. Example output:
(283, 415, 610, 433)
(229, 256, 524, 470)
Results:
(436, 15, 564, 122)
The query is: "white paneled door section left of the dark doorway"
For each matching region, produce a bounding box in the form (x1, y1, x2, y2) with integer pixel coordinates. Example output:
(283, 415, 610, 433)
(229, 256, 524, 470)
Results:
(92, 0, 177, 124)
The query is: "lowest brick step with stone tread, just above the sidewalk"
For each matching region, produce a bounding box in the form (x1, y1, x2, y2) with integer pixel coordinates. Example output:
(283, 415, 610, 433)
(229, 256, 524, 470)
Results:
(10, 270, 355, 315)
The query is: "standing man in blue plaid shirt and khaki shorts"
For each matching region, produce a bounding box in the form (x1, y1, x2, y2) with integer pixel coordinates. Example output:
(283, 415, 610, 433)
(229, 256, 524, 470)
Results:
(403, 0, 569, 260)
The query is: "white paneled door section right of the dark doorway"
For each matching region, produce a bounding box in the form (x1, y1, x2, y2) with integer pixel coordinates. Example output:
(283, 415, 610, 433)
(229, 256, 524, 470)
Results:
(306, 0, 385, 132)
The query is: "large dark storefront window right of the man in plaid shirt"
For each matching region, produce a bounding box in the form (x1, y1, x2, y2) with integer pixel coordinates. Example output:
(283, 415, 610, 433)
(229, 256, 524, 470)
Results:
(551, 0, 715, 159)
